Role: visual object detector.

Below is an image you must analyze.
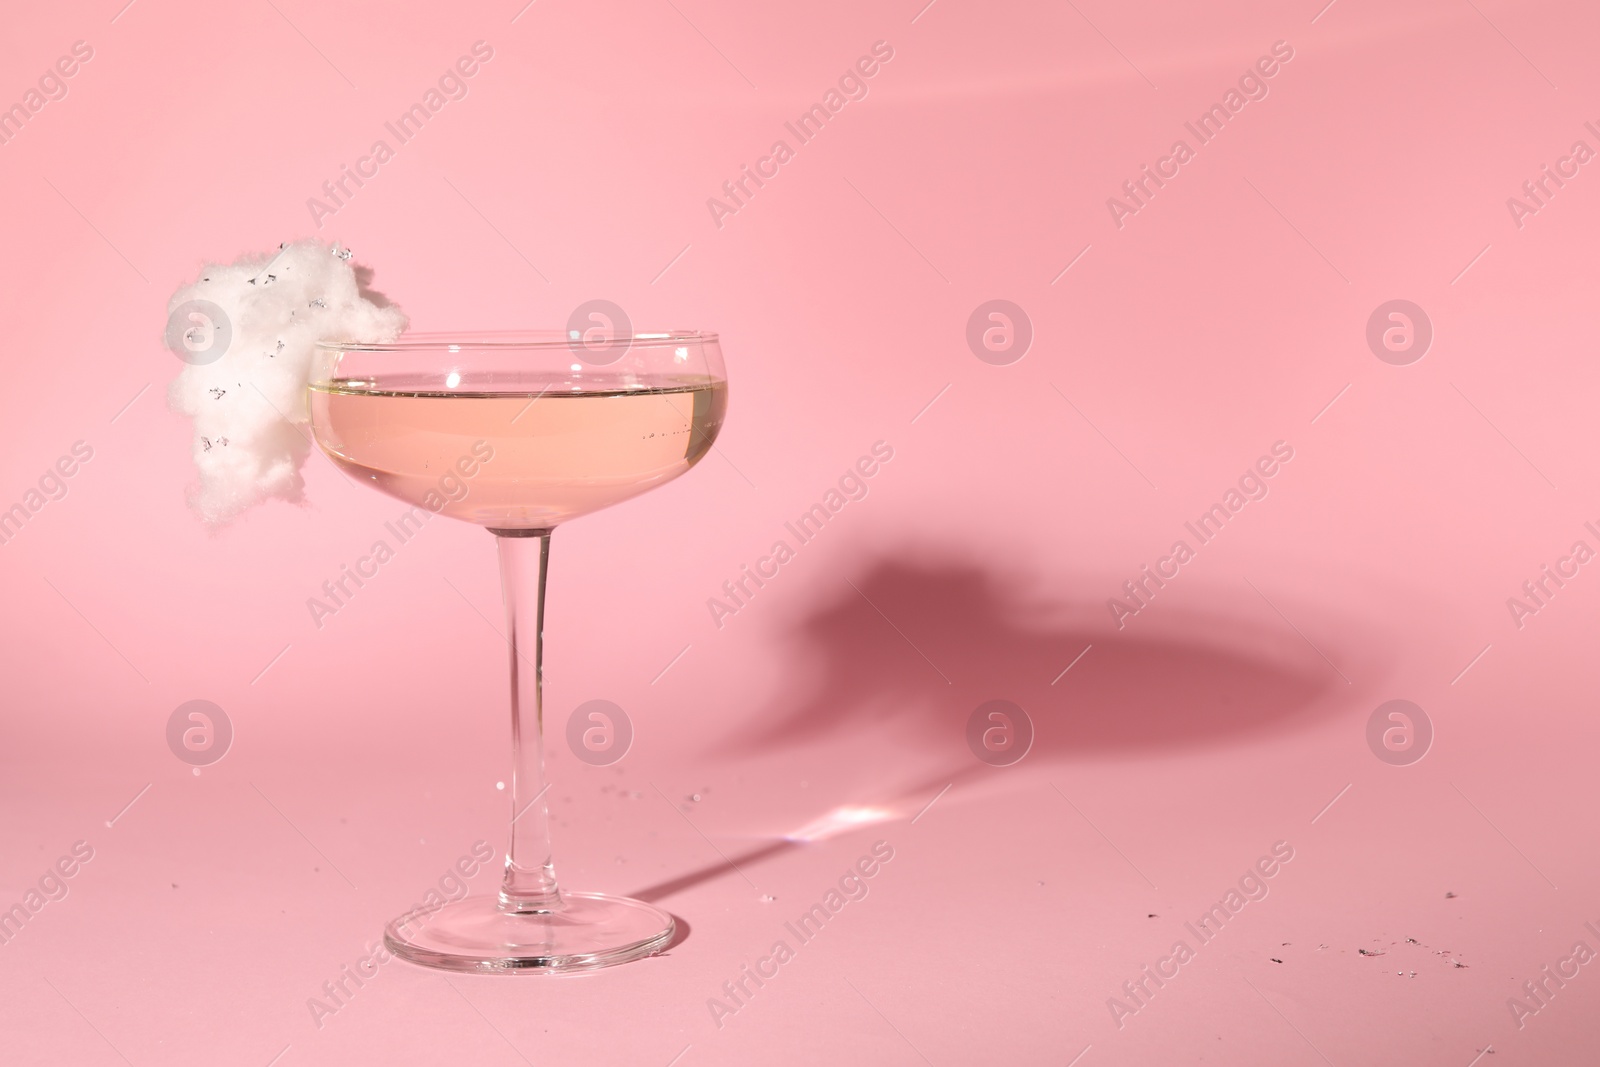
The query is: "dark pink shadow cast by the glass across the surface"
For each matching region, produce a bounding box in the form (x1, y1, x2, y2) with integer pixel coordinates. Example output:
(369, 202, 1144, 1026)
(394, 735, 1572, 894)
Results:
(632, 557, 1379, 901)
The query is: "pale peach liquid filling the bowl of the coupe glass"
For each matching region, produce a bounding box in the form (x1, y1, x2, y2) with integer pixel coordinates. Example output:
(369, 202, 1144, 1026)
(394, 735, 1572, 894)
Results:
(310, 378, 728, 530)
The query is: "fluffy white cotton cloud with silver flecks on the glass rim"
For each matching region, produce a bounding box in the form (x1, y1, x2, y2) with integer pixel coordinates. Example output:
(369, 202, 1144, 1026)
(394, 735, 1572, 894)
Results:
(166, 240, 406, 526)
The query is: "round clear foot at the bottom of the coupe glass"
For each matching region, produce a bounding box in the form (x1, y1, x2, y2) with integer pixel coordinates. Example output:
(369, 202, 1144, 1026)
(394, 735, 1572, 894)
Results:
(384, 893, 677, 974)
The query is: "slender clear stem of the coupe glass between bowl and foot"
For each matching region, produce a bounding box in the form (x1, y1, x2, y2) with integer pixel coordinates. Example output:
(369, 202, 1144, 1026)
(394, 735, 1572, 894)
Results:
(490, 530, 562, 913)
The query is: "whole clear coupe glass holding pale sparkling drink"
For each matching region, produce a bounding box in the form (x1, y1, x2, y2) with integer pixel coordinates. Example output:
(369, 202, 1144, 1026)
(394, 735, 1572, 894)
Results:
(310, 331, 728, 973)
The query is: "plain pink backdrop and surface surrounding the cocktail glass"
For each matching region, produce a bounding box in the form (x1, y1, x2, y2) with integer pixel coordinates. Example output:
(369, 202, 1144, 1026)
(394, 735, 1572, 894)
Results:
(0, 0, 1600, 1067)
